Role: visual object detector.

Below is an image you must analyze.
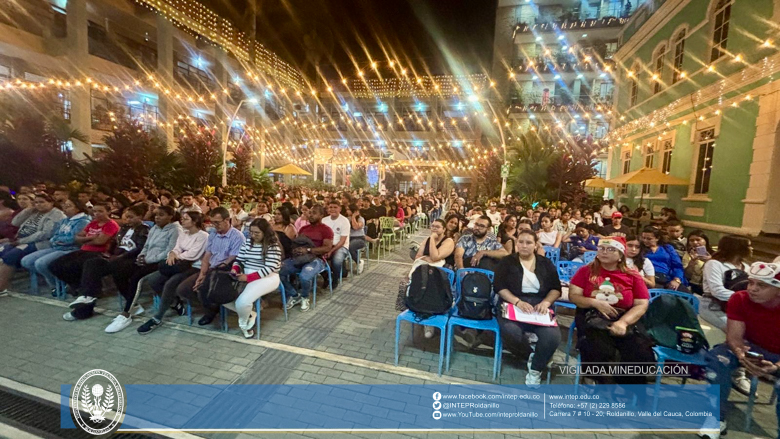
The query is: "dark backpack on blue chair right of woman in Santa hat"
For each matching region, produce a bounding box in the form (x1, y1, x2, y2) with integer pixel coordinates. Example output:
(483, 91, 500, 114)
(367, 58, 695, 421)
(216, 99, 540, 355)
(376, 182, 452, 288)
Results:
(642, 294, 709, 349)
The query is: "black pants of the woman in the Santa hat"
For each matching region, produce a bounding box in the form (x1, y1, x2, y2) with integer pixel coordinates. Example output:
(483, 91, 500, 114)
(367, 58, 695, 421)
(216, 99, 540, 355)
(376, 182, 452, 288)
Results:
(576, 312, 655, 384)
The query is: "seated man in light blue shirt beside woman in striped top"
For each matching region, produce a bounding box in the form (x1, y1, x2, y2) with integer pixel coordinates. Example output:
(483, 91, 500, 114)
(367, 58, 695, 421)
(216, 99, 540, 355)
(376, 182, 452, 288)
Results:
(138, 206, 246, 335)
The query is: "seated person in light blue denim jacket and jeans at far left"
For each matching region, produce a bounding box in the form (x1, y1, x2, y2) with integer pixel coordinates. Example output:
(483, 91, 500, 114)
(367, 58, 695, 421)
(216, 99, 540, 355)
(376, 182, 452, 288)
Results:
(21, 199, 90, 291)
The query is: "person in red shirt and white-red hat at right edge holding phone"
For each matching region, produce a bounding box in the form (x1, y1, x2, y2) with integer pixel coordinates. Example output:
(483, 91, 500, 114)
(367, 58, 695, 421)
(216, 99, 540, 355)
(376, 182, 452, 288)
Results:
(706, 262, 780, 438)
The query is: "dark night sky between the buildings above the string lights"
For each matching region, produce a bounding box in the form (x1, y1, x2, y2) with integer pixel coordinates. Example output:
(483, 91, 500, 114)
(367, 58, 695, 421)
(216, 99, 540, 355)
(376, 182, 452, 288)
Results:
(201, 0, 497, 77)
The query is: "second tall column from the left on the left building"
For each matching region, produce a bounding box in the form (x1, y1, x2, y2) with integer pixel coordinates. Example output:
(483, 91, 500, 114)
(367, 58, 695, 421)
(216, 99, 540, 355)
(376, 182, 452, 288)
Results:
(155, 14, 176, 150)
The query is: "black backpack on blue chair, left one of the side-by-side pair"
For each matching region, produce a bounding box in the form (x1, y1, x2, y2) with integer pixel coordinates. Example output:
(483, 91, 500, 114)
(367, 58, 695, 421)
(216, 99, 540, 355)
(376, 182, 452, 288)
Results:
(406, 265, 452, 320)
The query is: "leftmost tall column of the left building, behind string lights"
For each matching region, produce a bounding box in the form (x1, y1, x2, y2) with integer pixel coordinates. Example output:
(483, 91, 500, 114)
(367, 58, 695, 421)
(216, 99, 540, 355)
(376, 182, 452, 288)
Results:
(66, 0, 92, 160)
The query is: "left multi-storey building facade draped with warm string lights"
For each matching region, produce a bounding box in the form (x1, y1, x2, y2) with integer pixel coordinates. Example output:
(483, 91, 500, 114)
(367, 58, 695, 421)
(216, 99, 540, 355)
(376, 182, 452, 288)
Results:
(0, 0, 309, 166)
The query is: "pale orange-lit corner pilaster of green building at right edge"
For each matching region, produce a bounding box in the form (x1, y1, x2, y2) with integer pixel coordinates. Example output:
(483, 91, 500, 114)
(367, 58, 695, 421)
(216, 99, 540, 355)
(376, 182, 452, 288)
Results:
(742, 82, 780, 235)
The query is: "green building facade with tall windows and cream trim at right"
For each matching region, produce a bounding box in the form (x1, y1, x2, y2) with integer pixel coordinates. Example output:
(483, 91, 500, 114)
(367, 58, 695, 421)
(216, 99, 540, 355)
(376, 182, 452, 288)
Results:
(609, 0, 780, 236)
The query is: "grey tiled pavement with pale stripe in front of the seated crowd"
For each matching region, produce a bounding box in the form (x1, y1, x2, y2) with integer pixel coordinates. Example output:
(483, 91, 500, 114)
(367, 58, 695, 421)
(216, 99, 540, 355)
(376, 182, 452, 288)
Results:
(0, 227, 776, 439)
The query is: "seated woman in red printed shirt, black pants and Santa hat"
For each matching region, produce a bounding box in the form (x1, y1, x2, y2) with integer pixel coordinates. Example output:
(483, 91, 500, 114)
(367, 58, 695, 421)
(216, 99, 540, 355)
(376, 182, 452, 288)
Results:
(569, 237, 655, 384)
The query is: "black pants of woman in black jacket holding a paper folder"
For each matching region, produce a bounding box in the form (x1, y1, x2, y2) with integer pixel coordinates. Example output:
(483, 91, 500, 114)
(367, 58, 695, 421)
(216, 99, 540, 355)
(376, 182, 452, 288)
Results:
(498, 316, 561, 372)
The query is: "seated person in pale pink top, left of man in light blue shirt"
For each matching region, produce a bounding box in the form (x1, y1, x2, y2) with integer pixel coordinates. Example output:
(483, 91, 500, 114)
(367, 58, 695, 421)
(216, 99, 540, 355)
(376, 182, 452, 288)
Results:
(137, 211, 209, 335)
